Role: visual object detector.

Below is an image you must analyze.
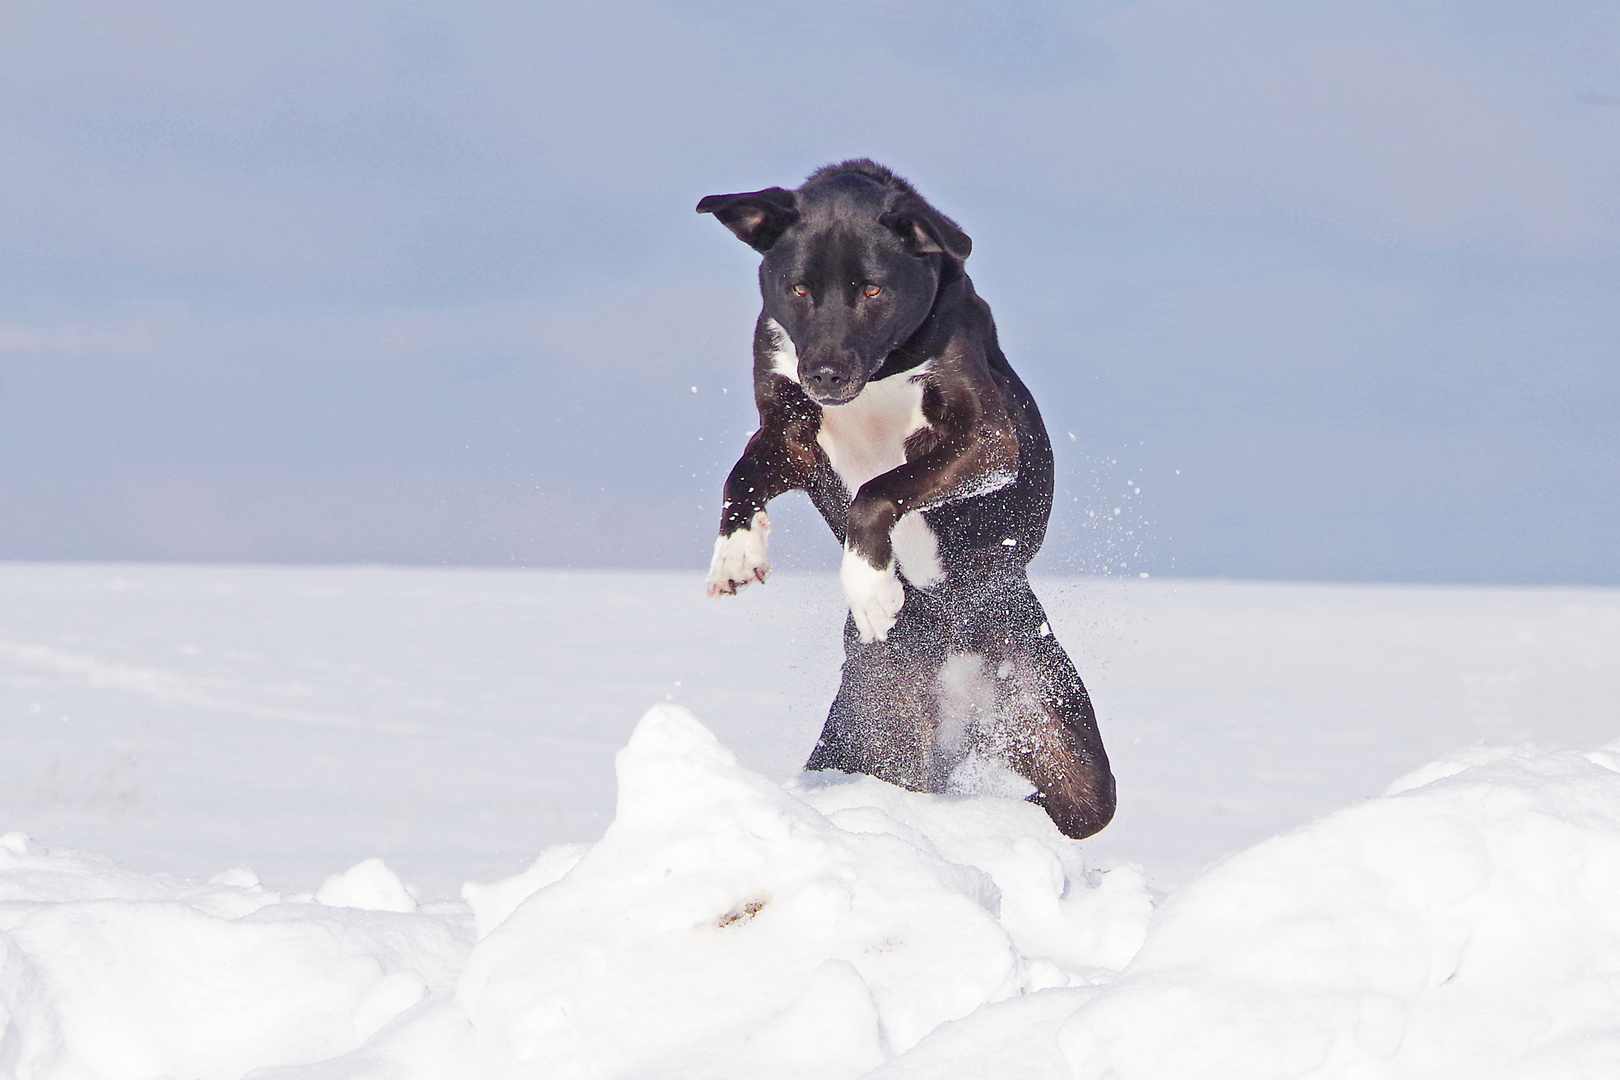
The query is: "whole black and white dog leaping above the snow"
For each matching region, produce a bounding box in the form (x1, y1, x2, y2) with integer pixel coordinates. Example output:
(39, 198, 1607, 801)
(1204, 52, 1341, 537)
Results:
(697, 160, 1115, 837)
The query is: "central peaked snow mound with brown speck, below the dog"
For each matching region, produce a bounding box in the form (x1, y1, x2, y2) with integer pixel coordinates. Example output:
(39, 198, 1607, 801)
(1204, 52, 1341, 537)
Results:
(458, 706, 1150, 1078)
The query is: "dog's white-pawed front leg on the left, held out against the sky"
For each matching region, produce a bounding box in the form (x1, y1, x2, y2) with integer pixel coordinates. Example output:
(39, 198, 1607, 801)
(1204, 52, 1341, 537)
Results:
(706, 426, 804, 596)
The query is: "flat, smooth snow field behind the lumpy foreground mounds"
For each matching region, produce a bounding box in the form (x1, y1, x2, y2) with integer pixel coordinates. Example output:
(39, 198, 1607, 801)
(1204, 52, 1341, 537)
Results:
(0, 566, 1620, 899)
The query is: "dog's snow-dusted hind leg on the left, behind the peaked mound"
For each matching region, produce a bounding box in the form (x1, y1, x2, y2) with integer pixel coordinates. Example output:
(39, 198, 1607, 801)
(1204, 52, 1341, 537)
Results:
(805, 586, 944, 792)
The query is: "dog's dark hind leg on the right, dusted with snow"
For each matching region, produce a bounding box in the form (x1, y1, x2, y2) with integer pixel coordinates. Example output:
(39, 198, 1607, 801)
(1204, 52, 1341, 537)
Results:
(970, 567, 1115, 839)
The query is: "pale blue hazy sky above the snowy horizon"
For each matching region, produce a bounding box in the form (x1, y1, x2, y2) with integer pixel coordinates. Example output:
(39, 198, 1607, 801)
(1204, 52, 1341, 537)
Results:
(0, 0, 1620, 585)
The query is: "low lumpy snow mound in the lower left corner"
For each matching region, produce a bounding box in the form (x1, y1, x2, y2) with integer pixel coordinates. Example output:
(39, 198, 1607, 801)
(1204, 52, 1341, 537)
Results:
(0, 832, 471, 1080)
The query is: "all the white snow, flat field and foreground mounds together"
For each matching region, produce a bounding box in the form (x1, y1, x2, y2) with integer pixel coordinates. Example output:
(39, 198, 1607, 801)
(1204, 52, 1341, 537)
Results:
(0, 565, 1620, 1080)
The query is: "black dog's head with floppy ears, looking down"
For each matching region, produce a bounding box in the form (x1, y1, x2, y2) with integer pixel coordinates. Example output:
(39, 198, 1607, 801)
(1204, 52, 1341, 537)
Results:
(698, 160, 974, 405)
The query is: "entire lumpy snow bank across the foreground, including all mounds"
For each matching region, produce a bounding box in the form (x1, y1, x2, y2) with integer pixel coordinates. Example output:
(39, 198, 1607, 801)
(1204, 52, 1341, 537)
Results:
(0, 706, 1620, 1080)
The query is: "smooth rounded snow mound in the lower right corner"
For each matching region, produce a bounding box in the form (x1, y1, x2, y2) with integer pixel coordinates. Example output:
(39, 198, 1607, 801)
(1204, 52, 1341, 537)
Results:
(1059, 748, 1620, 1080)
